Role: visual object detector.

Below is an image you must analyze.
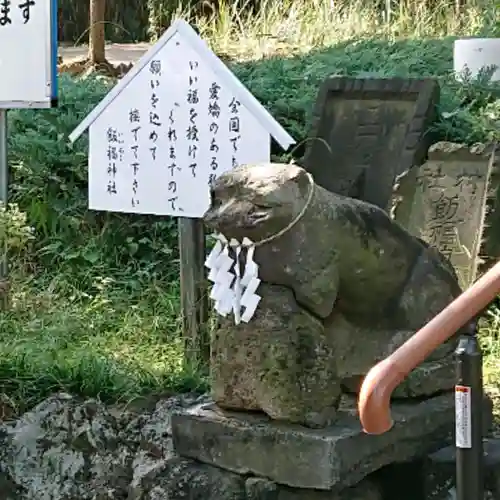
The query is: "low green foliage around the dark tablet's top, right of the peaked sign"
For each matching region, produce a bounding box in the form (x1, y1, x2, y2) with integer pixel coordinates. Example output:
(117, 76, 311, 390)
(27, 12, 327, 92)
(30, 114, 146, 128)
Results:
(230, 38, 500, 144)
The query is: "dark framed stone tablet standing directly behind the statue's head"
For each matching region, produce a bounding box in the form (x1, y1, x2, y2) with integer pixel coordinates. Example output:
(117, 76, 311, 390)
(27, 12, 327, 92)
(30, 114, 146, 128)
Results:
(304, 77, 439, 210)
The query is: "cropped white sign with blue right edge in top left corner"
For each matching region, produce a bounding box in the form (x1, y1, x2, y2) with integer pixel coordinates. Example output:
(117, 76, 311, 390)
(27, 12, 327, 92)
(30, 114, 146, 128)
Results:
(0, 0, 57, 108)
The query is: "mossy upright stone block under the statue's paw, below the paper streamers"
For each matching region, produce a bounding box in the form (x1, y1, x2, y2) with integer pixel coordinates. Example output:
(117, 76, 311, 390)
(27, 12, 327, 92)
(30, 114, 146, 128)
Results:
(212, 284, 341, 427)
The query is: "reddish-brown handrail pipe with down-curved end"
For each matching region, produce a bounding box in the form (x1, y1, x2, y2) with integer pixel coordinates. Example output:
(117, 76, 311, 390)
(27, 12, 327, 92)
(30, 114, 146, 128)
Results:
(358, 262, 500, 434)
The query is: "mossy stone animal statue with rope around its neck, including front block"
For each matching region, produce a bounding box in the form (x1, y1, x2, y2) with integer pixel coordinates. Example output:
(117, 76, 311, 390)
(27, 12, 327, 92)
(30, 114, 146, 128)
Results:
(204, 164, 461, 427)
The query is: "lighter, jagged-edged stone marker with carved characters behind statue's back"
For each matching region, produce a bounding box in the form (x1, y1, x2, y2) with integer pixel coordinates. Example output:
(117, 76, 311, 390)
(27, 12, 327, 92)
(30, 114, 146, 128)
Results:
(394, 142, 496, 288)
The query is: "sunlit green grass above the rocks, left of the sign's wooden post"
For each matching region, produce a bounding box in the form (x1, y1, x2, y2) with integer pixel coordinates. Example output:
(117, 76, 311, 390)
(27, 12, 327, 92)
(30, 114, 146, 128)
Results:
(0, 277, 200, 406)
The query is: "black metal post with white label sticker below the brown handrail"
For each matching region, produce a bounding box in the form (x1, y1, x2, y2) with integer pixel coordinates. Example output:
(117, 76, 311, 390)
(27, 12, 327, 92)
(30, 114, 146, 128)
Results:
(455, 320, 484, 500)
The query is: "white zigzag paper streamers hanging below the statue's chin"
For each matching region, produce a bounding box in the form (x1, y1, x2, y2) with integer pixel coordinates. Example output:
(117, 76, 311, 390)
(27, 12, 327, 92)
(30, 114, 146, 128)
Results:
(205, 234, 261, 325)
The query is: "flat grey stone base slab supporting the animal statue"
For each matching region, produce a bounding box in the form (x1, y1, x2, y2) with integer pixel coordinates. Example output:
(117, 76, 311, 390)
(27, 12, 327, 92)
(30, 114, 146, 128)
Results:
(172, 393, 455, 491)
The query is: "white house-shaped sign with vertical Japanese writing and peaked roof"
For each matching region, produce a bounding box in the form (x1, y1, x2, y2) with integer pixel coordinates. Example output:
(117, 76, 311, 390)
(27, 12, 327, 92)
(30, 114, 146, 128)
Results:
(70, 20, 294, 217)
